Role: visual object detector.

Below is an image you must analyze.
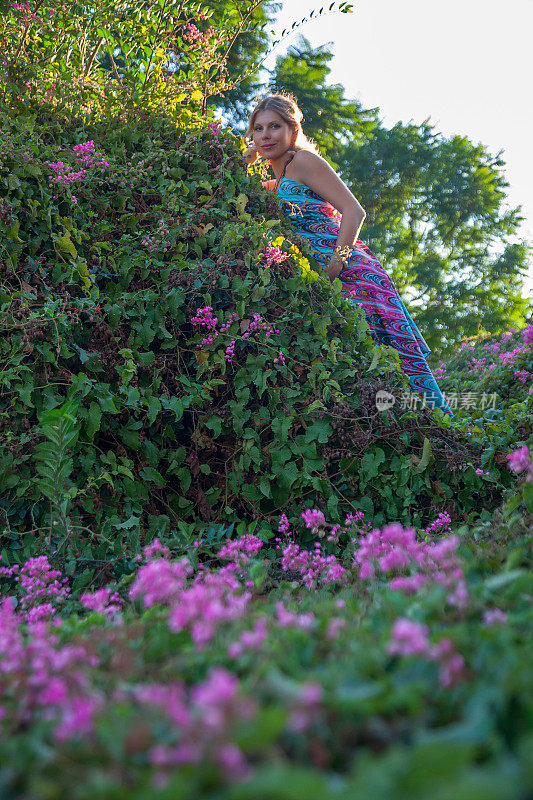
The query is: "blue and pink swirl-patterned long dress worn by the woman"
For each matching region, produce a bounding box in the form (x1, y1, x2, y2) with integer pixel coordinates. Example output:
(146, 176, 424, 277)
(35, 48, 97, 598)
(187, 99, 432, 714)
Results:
(277, 175, 454, 417)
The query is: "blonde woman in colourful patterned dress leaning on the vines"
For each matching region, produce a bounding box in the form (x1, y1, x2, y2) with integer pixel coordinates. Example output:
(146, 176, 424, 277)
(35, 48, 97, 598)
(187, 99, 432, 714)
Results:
(245, 94, 454, 417)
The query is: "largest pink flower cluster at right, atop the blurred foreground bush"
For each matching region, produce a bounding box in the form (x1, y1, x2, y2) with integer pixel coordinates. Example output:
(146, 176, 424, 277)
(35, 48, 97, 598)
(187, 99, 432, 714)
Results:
(354, 523, 468, 608)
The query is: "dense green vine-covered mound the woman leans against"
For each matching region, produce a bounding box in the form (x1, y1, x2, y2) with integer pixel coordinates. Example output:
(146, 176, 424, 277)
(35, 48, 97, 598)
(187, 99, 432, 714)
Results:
(0, 112, 524, 580)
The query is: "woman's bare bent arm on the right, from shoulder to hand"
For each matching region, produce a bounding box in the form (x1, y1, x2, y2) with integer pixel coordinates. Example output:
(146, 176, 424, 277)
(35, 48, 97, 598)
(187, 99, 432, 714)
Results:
(288, 150, 366, 281)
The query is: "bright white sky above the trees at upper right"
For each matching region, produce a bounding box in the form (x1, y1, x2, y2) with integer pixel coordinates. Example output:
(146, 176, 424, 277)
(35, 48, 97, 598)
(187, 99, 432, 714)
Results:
(266, 0, 533, 297)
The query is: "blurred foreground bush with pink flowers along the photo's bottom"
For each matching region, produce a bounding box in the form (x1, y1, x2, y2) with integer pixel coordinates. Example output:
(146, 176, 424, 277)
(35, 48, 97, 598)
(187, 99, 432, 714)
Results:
(0, 509, 532, 800)
